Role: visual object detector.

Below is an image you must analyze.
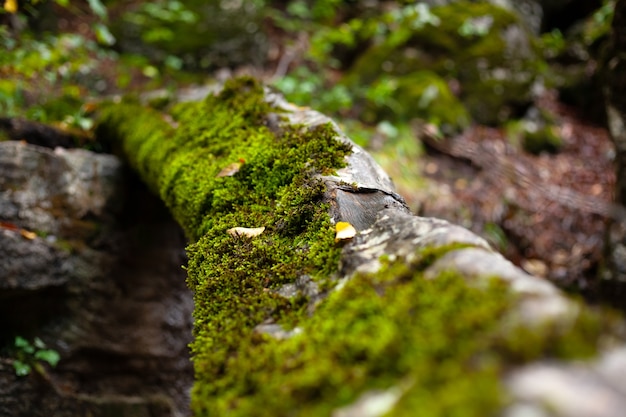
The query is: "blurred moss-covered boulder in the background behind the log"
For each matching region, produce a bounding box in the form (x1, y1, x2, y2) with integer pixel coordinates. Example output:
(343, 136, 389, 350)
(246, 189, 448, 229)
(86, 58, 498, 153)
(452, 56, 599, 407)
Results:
(344, 1, 546, 127)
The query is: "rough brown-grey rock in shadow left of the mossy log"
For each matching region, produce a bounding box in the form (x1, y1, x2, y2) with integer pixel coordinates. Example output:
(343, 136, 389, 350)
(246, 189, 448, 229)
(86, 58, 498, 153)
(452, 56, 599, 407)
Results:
(0, 142, 192, 417)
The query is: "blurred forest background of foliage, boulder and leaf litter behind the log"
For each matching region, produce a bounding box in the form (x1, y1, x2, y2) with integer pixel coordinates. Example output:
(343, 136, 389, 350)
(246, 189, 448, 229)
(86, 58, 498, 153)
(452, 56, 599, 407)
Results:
(0, 0, 619, 300)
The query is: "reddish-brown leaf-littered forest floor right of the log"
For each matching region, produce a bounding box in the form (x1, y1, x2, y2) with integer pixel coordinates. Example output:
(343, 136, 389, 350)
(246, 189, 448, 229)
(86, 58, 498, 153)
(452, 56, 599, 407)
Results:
(376, 92, 615, 300)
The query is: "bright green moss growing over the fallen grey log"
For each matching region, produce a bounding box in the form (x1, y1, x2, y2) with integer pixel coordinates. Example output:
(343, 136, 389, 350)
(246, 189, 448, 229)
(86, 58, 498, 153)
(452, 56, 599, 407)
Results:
(98, 79, 616, 417)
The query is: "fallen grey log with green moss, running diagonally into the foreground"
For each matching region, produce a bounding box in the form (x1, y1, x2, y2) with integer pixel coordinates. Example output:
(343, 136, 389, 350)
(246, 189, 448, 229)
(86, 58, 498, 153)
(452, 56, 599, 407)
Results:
(98, 78, 626, 416)
